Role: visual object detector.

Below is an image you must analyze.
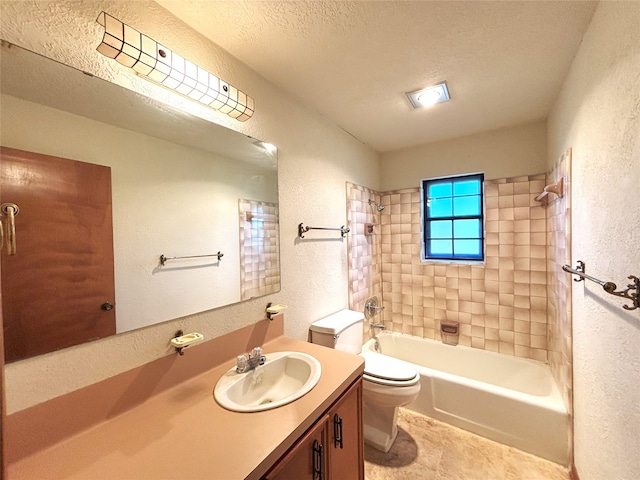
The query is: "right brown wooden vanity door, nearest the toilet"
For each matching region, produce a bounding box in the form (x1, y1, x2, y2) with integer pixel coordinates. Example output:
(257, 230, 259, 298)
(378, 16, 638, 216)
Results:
(327, 379, 364, 480)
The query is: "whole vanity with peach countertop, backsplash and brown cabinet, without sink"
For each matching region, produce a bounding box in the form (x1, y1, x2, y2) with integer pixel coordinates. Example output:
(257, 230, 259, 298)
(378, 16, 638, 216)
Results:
(6, 334, 364, 480)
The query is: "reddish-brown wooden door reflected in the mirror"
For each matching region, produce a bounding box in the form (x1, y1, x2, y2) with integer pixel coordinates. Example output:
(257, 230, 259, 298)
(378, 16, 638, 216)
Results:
(0, 147, 116, 362)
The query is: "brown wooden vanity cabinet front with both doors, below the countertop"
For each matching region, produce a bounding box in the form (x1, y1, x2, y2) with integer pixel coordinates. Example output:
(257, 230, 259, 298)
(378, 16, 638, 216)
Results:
(263, 378, 364, 480)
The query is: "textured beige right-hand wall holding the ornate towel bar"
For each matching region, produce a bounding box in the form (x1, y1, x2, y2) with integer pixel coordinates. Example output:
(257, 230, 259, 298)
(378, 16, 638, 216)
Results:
(548, 2, 640, 480)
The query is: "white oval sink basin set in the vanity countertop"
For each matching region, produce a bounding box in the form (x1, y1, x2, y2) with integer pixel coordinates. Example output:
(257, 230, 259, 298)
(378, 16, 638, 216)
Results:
(213, 352, 321, 412)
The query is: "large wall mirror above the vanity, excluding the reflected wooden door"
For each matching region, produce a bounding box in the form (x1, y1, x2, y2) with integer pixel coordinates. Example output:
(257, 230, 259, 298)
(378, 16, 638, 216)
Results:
(0, 42, 280, 361)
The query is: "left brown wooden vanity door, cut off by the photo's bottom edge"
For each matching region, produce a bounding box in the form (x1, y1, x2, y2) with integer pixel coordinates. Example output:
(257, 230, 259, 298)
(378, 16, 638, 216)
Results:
(264, 415, 328, 480)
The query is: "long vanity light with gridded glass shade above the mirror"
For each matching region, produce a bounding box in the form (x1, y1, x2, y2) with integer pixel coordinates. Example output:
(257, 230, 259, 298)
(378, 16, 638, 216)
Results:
(96, 12, 255, 122)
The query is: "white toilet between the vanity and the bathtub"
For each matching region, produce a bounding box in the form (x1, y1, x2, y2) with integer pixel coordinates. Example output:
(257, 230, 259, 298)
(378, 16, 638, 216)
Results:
(310, 310, 420, 452)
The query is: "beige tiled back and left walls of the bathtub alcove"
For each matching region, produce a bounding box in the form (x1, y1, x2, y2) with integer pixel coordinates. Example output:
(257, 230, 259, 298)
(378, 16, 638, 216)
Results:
(347, 174, 548, 361)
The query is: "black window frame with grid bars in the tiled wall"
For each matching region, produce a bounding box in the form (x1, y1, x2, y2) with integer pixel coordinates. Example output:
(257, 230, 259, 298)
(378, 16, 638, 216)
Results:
(420, 172, 486, 264)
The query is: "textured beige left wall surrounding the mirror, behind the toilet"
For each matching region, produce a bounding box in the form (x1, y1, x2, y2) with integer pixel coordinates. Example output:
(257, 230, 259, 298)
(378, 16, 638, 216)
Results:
(0, 1, 379, 413)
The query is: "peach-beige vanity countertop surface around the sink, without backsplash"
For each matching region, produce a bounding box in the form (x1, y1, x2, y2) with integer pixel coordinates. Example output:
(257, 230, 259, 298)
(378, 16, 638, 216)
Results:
(8, 337, 364, 480)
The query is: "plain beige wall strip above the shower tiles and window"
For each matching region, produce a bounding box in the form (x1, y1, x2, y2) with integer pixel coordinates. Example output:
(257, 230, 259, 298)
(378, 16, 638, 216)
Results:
(380, 121, 547, 191)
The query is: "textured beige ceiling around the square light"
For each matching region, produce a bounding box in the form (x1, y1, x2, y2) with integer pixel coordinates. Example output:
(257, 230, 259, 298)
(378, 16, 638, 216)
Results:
(157, 0, 596, 152)
